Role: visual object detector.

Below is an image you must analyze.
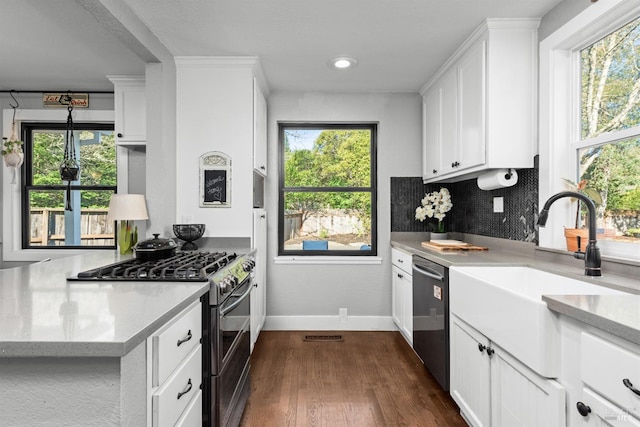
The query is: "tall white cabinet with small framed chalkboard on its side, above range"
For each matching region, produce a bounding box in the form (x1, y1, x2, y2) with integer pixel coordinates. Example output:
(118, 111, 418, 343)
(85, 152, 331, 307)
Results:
(176, 57, 269, 238)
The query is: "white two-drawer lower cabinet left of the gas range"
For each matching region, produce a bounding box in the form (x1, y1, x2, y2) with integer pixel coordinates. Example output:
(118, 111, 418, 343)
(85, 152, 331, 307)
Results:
(147, 301, 202, 427)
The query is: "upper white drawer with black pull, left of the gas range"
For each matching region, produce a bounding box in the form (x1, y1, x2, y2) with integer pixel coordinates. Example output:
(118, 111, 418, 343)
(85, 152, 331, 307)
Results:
(151, 301, 202, 387)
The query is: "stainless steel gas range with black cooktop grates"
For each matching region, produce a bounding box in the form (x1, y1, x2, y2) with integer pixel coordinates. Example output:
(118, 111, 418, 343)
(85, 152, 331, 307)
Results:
(68, 251, 255, 426)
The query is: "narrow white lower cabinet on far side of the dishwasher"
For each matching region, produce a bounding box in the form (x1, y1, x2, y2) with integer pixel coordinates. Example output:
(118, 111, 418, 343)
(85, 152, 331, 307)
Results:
(391, 248, 413, 345)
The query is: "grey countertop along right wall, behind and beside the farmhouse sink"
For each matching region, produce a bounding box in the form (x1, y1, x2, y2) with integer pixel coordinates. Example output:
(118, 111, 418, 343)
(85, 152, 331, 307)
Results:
(391, 233, 640, 345)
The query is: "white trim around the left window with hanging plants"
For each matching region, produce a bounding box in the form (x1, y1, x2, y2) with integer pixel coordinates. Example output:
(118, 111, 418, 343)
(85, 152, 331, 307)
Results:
(1, 109, 116, 261)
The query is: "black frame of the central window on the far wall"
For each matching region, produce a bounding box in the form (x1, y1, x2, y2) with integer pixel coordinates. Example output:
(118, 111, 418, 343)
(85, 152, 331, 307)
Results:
(278, 121, 378, 258)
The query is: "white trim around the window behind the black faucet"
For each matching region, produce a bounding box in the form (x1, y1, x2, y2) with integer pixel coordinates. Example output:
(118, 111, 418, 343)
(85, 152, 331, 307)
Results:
(538, 0, 640, 260)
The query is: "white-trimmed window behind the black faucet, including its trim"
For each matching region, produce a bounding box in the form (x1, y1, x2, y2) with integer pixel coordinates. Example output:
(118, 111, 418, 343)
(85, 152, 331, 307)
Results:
(540, 0, 640, 261)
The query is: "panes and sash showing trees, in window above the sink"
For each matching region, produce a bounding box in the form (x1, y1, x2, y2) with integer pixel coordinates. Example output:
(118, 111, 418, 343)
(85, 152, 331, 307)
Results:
(573, 18, 640, 251)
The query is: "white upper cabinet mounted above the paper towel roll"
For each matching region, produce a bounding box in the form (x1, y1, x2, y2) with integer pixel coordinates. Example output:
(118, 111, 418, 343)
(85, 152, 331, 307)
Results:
(420, 19, 539, 183)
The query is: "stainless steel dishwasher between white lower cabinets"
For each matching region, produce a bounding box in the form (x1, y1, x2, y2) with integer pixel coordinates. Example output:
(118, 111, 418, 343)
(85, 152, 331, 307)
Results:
(413, 255, 449, 391)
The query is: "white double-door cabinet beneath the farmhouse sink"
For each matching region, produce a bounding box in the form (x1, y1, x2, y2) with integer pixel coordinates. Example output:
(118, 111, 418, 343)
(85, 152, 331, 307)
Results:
(450, 313, 565, 427)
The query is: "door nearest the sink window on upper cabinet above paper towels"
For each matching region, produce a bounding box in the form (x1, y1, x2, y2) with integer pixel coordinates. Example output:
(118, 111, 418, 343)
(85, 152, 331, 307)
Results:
(457, 40, 486, 169)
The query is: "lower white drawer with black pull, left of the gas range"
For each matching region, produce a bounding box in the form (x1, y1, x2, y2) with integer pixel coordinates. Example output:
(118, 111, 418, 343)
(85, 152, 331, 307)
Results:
(151, 345, 202, 427)
